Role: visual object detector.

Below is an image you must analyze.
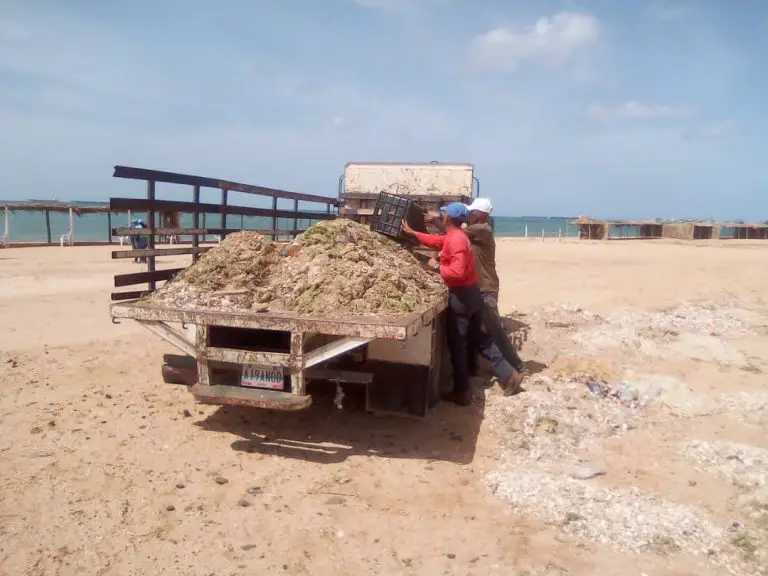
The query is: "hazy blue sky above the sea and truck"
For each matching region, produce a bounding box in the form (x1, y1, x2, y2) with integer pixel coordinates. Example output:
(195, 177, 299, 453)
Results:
(0, 0, 768, 220)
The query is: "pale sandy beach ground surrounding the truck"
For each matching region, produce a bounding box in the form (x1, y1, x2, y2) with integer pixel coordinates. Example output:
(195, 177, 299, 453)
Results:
(0, 240, 768, 576)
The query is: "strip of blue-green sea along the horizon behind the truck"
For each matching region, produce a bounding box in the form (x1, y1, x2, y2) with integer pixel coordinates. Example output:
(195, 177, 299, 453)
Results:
(0, 200, 578, 243)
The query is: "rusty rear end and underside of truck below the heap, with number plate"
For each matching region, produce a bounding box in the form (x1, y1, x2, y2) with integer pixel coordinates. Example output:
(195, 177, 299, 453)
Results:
(110, 300, 447, 416)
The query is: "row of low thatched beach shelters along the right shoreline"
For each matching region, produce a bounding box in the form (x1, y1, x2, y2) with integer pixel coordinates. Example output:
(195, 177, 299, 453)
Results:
(569, 216, 768, 240)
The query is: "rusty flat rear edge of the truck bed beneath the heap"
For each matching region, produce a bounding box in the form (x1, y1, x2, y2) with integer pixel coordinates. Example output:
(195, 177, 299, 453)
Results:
(110, 298, 448, 340)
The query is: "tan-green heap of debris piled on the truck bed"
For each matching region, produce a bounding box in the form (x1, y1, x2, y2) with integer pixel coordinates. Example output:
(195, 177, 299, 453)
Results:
(150, 219, 446, 316)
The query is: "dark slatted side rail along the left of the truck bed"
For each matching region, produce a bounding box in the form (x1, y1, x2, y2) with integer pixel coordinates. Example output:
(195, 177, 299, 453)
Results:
(109, 166, 339, 301)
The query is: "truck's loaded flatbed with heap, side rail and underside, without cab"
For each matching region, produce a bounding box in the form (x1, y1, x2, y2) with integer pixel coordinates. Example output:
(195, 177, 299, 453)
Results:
(110, 167, 450, 416)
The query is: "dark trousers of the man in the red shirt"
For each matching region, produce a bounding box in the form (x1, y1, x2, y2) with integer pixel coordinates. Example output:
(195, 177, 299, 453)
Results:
(448, 286, 514, 394)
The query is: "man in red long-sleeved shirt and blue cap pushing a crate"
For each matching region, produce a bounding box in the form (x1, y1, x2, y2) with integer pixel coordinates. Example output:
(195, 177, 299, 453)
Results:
(403, 202, 522, 406)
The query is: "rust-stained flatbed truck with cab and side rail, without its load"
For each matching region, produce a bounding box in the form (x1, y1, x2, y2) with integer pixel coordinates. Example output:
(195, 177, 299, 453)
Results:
(110, 163, 479, 417)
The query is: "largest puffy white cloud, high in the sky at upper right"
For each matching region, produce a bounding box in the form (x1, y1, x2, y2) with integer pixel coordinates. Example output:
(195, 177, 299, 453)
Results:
(471, 12, 600, 70)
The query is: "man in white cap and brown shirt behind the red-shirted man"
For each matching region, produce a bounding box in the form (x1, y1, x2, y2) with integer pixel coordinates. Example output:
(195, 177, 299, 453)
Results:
(425, 198, 525, 374)
